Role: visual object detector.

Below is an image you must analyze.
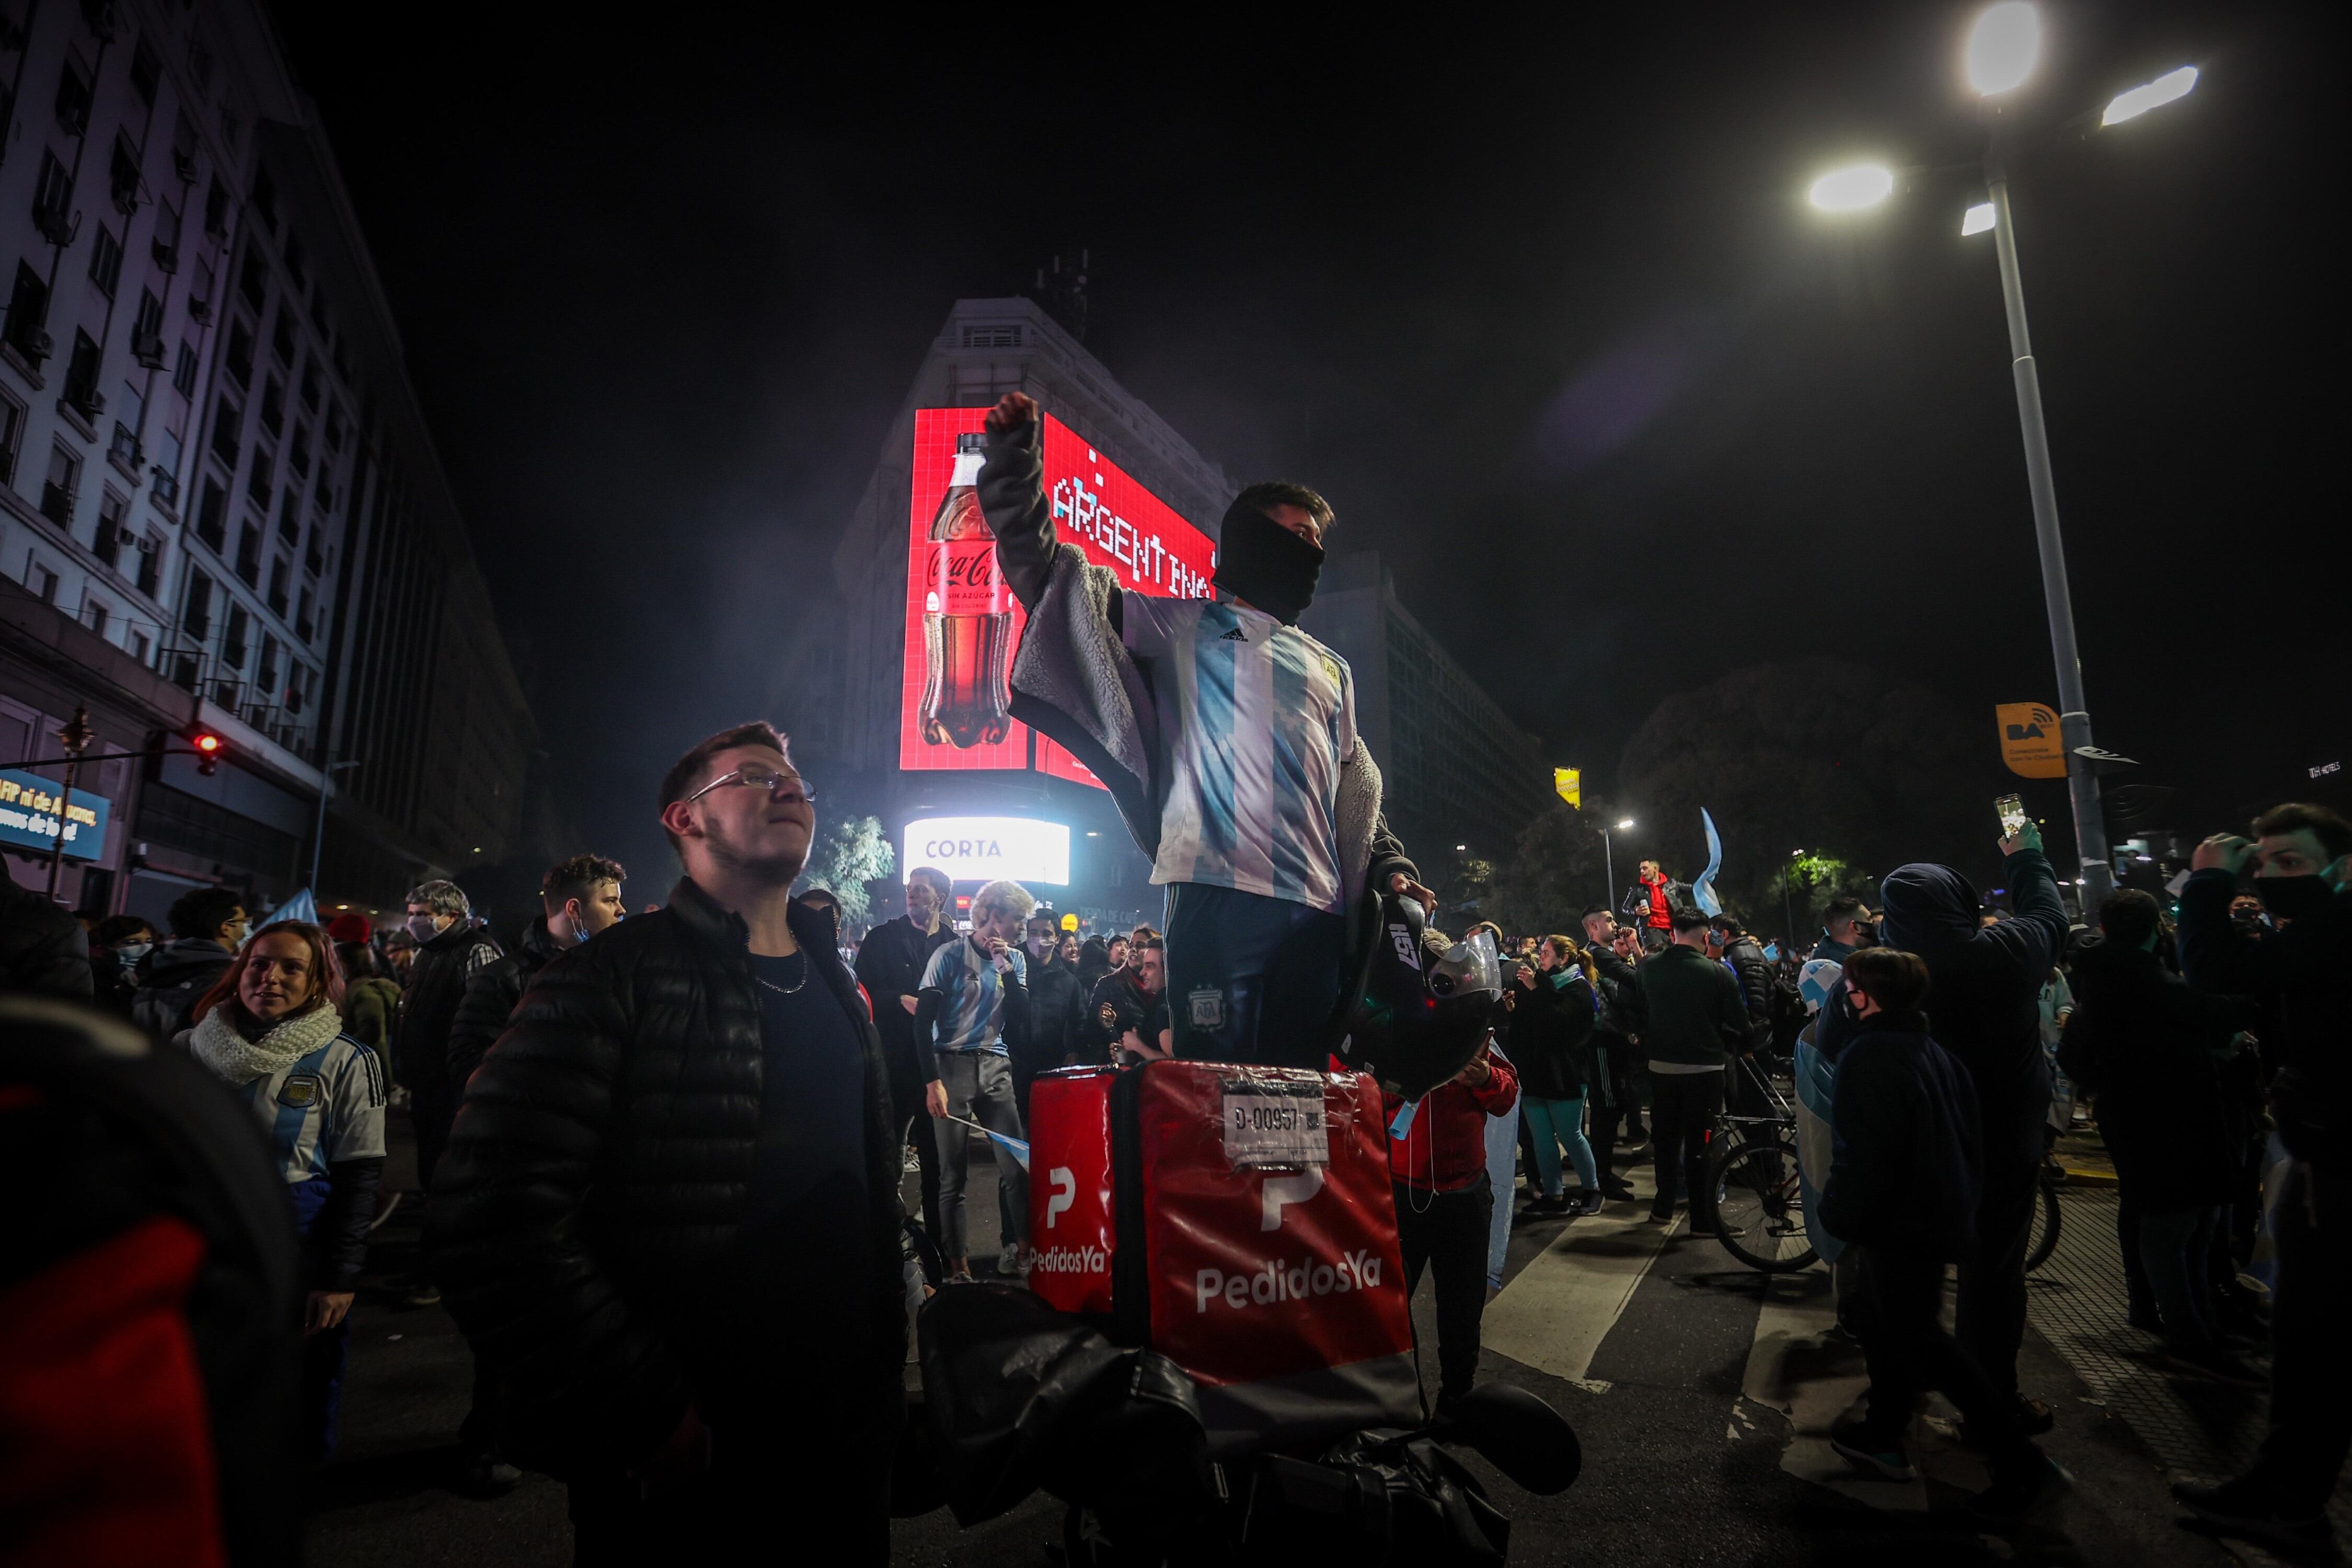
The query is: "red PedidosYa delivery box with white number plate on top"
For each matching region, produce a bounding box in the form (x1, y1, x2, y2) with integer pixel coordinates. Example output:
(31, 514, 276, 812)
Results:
(1030, 1060, 1421, 1455)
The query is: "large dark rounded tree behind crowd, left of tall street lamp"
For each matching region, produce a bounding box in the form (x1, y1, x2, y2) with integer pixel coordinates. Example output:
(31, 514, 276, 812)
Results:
(1618, 661, 2004, 926)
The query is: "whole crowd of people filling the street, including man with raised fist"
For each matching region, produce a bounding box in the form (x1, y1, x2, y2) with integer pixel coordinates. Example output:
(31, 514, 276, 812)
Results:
(0, 393, 2352, 1563)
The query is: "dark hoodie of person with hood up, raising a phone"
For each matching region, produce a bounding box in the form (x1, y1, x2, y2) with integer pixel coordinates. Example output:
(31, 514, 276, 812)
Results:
(1872, 849, 2068, 1180)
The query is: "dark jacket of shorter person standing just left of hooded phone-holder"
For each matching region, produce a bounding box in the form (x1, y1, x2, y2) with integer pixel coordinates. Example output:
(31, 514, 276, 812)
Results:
(1820, 1013, 1983, 1260)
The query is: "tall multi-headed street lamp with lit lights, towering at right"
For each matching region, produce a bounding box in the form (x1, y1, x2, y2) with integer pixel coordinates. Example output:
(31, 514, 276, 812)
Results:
(1809, 0, 2197, 907)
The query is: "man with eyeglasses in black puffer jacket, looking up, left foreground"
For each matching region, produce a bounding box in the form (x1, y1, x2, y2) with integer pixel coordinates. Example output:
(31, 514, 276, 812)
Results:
(431, 724, 906, 1563)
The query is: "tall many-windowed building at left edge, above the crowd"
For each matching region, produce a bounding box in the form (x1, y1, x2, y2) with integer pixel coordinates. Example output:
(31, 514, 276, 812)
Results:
(0, 0, 534, 924)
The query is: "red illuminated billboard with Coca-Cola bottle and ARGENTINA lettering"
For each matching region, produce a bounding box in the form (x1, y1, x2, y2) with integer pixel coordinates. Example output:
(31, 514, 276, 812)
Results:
(898, 409, 1216, 783)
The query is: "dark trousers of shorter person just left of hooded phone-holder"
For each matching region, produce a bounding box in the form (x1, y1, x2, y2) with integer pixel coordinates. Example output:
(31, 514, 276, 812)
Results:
(1847, 1246, 2035, 1474)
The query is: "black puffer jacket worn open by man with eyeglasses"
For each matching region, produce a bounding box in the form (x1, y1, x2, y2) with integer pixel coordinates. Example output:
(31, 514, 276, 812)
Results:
(428, 882, 906, 1477)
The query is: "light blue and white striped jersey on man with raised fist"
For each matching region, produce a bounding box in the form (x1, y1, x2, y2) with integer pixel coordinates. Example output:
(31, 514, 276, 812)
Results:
(1120, 592, 1355, 915)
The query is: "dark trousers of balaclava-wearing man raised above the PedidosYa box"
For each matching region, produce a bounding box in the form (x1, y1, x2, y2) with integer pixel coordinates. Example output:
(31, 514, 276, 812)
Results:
(1167, 882, 1348, 1072)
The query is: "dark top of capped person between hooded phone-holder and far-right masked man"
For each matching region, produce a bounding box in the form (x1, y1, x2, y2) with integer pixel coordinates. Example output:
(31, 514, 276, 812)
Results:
(2058, 936, 2256, 1213)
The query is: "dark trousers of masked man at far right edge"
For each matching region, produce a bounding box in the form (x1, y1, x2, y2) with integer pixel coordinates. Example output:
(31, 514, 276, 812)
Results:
(2256, 1159, 2352, 1514)
